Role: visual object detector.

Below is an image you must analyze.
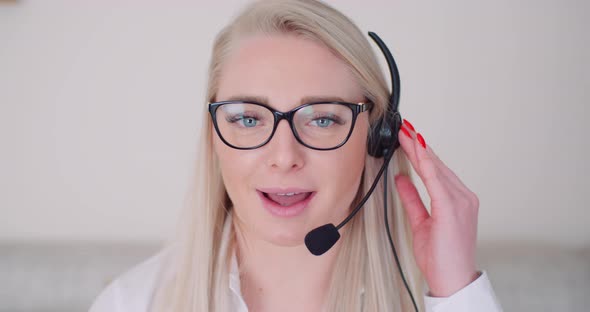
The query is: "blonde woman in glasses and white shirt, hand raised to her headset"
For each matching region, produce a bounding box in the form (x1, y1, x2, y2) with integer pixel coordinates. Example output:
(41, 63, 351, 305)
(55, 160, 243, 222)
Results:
(91, 0, 501, 311)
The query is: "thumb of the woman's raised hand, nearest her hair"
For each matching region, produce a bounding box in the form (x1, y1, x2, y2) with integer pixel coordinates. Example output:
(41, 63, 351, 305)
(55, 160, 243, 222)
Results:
(394, 175, 430, 231)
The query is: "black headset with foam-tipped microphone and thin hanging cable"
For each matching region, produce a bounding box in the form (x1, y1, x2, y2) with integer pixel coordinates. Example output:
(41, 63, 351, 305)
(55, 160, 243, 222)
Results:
(305, 32, 418, 312)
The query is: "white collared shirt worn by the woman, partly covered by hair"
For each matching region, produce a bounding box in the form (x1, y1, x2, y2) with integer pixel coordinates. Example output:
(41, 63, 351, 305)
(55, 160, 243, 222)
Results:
(90, 251, 502, 312)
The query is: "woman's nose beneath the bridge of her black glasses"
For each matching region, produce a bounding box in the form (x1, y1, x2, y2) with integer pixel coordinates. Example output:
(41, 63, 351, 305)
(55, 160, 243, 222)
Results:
(265, 120, 305, 172)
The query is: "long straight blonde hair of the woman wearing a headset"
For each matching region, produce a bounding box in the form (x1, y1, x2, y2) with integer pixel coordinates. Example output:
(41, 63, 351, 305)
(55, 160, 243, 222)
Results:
(152, 0, 424, 311)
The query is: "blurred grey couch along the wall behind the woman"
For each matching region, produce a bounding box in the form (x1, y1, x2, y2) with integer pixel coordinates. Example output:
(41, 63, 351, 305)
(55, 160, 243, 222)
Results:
(0, 242, 590, 312)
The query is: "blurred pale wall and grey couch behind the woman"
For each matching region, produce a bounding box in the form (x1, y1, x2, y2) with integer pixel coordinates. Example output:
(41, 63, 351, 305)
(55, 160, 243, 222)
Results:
(0, 0, 590, 311)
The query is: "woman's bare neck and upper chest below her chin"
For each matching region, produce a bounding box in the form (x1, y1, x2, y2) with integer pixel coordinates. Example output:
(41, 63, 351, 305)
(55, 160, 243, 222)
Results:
(233, 218, 340, 311)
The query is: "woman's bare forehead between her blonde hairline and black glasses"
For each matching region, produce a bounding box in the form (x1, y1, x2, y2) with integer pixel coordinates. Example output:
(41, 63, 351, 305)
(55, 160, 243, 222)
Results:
(217, 34, 363, 109)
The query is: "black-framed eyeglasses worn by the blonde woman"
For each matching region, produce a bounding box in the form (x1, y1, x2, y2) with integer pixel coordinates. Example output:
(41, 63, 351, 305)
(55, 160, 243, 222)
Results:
(209, 101, 373, 150)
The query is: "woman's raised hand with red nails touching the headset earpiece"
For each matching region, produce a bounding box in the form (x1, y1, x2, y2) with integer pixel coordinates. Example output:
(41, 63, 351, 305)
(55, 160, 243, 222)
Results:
(395, 119, 479, 297)
